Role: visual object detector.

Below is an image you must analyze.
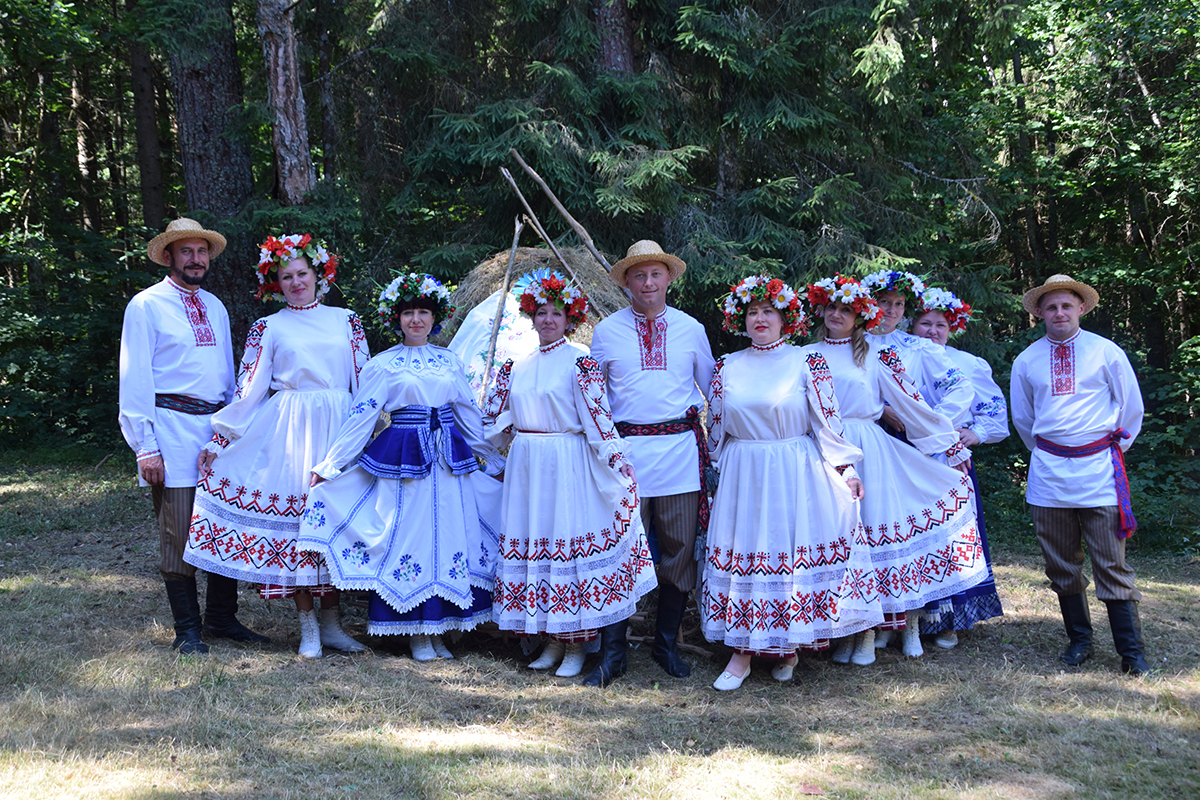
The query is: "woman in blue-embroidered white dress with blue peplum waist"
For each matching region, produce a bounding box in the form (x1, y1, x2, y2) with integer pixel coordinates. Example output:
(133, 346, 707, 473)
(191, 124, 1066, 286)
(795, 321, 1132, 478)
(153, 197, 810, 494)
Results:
(300, 272, 504, 661)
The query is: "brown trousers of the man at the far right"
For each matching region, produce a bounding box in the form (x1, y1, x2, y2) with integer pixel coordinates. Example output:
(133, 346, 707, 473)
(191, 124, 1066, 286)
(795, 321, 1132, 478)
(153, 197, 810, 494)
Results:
(1030, 505, 1141, 601)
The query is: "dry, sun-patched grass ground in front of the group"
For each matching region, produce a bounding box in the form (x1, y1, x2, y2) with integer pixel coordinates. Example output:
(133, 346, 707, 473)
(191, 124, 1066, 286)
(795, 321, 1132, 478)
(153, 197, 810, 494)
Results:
(0, 465, 1200, 800)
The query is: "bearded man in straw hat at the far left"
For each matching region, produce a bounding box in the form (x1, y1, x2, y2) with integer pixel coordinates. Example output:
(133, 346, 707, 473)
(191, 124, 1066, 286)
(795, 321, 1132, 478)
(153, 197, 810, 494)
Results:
(119, 218, 270, 654)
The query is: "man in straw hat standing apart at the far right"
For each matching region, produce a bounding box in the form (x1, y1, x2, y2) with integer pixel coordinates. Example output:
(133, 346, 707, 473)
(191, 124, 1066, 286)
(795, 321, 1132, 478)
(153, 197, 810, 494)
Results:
(1012, 275, 1150, 675)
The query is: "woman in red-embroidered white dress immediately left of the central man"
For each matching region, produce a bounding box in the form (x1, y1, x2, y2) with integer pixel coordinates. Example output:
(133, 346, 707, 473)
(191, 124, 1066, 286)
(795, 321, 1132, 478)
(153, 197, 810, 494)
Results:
(485, 270, 658, 678)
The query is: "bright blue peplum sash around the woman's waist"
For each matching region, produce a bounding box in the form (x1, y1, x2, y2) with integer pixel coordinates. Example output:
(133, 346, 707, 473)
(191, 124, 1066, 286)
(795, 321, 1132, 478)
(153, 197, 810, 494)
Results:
(359, 403, 479, 479)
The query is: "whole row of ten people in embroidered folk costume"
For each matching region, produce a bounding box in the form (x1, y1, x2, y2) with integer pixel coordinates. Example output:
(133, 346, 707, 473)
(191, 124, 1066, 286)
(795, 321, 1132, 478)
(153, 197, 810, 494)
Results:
(120, 218, 1150, 691)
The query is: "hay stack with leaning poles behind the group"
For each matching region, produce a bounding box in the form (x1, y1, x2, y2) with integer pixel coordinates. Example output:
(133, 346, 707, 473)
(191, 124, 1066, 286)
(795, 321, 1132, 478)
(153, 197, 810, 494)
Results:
(437, 247, 629, 344)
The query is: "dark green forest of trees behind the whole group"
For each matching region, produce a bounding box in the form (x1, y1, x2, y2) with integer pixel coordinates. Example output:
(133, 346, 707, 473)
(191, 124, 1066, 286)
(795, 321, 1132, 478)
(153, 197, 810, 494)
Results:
(0, 0, 1200, 554)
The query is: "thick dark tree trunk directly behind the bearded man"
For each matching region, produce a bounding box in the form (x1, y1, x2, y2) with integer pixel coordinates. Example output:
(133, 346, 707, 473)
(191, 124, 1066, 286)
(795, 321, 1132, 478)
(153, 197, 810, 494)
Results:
(169, 0, 255, 351)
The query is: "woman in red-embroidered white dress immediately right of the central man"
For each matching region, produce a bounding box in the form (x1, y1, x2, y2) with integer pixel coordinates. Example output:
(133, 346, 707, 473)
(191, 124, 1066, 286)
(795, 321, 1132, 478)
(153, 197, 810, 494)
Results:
(700, 275, 883, 691)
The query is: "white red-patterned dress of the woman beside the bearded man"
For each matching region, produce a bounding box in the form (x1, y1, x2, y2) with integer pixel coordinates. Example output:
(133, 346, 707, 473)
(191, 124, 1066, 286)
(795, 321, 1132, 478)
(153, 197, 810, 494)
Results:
(184, 303, 370, 597)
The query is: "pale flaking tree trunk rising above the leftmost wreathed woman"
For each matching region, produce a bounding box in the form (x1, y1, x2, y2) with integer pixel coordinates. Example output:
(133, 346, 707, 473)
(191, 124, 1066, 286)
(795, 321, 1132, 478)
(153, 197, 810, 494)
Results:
(258, 0, 317, 205)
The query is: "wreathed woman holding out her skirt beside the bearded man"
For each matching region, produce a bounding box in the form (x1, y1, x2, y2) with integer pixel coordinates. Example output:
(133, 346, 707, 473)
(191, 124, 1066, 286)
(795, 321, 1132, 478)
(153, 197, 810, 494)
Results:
(184, 234, 370, 658)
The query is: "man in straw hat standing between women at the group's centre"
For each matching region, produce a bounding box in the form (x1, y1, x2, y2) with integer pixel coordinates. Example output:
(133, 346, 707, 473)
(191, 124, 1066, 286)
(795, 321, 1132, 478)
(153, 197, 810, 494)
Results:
(583, 240, 714, 686)
